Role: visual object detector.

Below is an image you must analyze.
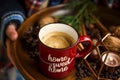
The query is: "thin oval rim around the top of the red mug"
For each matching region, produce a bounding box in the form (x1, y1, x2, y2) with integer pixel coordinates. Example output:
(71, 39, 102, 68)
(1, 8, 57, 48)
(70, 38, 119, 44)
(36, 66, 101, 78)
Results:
(38, 22, 79, 50)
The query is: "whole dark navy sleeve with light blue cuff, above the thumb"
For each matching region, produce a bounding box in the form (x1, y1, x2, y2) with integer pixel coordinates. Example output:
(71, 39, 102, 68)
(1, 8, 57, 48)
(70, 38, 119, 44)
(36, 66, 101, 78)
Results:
(0, 0, 25, 45)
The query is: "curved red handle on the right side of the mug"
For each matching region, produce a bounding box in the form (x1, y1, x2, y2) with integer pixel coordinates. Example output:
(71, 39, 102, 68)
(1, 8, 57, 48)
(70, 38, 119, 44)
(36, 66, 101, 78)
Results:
(76, 36, 92, 58)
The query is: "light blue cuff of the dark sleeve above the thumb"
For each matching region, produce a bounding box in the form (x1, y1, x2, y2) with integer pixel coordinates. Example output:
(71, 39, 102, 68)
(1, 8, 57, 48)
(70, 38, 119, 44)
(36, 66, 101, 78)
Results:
(0, 11, 25, 45)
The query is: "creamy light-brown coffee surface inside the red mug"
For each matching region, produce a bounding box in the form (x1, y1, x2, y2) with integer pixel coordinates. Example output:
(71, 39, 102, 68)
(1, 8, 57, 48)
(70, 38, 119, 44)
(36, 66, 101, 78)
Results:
(41, 31, 75, 49)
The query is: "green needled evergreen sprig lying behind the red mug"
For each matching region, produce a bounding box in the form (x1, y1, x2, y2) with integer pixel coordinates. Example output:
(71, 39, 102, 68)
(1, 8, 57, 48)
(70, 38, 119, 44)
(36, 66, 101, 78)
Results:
(59, 0, 97, 33)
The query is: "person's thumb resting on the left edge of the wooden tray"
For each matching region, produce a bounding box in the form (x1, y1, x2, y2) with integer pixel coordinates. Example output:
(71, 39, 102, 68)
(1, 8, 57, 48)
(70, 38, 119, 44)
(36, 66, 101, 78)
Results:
(6, 24, 18, 41)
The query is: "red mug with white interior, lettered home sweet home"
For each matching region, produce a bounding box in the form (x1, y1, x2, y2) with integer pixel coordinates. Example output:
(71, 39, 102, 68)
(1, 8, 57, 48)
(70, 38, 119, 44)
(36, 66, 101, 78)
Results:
(39, 23, 92, 78)
